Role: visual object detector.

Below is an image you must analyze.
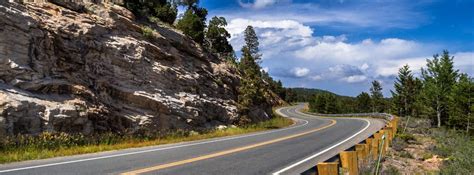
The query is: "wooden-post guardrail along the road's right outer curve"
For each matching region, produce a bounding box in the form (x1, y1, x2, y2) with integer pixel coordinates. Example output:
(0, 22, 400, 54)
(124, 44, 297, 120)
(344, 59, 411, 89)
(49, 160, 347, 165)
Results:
(316, 113, 399, 175)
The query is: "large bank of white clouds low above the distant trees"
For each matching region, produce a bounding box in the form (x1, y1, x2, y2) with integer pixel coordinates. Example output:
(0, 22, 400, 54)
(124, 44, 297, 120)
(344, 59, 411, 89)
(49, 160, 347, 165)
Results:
(227, 18, 474, 87)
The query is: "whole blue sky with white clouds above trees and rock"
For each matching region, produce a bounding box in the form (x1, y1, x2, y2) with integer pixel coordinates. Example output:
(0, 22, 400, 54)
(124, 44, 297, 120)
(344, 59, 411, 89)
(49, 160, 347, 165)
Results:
(200, 0, 474, 96)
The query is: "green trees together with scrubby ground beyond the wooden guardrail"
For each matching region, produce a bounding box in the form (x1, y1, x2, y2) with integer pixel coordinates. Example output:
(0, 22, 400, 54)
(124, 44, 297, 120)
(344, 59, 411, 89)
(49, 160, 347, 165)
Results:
(308, 51, 474, 174)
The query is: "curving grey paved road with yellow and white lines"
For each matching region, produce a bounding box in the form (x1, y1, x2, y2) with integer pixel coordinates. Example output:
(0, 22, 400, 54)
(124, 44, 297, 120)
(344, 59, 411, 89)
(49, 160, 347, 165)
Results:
(0, 105, 384, 175)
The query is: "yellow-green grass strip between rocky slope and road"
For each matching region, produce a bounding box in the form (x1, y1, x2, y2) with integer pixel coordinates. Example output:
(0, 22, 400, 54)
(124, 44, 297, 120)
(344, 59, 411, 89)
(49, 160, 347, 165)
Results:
(0, 116, 293, 163)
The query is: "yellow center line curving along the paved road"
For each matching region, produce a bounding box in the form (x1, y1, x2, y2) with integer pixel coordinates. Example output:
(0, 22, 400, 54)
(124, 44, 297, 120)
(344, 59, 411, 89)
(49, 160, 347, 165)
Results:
(121, 120, 337, 175)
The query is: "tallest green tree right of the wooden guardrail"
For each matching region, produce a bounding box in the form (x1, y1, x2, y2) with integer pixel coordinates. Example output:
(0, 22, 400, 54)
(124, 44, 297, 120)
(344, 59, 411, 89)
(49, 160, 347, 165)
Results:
(421, 51, 458, 127)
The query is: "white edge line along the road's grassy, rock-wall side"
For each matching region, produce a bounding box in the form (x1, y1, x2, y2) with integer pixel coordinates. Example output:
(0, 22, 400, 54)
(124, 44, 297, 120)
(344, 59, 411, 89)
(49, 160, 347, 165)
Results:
(0, 108, 308, 173)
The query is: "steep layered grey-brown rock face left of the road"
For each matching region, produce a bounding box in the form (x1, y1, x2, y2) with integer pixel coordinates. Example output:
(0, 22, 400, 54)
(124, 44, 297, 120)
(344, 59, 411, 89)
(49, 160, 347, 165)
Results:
(0, 1, 280, 136)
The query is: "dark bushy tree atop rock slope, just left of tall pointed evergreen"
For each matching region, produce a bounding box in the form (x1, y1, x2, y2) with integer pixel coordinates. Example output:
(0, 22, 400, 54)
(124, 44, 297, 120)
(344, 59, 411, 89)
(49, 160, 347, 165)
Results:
(206, 16, 234, 56)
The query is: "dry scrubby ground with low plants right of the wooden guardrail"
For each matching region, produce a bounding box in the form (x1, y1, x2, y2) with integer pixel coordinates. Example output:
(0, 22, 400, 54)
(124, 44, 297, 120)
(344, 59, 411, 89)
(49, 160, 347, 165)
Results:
(382, 118, 474, 174)
